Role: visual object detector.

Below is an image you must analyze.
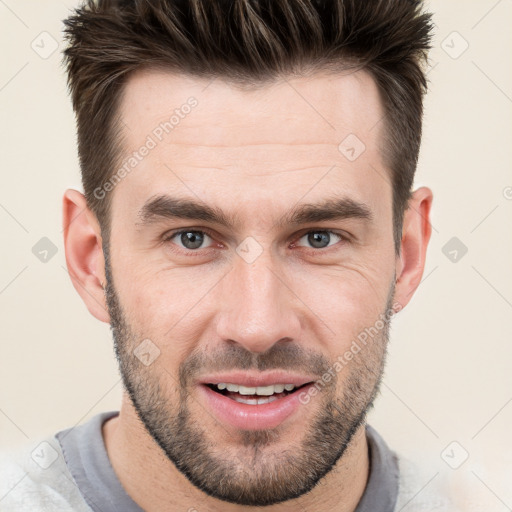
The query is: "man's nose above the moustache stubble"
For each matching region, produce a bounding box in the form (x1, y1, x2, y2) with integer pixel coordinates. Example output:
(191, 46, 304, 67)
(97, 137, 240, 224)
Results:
(216, 251, 301, 353)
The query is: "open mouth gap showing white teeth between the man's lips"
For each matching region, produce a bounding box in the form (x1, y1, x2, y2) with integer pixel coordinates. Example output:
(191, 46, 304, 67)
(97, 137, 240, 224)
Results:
(206, 382, 312, 405)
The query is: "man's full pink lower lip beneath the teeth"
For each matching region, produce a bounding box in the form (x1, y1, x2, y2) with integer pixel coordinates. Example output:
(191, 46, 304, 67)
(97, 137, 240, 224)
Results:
(199, 384, 313, 430)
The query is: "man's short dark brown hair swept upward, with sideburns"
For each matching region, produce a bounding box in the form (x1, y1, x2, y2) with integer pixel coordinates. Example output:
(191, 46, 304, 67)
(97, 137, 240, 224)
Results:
(64, 0, 432, 252)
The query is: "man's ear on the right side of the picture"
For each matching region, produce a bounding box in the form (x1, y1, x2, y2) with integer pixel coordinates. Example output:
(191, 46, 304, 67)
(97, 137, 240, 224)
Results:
(395, 187, 433, 308)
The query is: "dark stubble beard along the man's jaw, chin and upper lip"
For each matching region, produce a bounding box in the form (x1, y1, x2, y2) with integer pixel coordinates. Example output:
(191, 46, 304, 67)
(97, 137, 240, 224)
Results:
(105, 250, 394, 506)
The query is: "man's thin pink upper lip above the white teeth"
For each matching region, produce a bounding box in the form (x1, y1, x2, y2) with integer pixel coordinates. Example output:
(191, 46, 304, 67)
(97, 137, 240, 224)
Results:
(199, 371, 316, 387)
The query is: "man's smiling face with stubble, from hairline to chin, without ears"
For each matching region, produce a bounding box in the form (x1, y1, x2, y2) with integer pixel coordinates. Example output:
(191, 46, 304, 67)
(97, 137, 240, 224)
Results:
(107, 72, 396, 505)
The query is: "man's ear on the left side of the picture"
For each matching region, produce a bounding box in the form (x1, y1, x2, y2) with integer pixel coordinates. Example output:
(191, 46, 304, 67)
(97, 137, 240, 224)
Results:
(62, 189, 110, 323)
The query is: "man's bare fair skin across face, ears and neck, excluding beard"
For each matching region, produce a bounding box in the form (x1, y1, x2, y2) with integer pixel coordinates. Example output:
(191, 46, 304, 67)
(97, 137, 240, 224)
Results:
(63, 70, 432, 512)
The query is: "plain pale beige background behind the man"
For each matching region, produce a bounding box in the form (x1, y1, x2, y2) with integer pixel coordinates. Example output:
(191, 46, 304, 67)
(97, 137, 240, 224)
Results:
(0, 0, 512, 510)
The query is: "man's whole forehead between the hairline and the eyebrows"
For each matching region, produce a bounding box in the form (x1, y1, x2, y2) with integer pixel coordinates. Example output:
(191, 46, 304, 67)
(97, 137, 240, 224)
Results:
(114, 70, 389, 226)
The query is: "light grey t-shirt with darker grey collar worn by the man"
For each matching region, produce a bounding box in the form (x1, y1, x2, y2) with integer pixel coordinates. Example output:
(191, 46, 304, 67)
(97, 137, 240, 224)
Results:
(0, 411, 456, 512)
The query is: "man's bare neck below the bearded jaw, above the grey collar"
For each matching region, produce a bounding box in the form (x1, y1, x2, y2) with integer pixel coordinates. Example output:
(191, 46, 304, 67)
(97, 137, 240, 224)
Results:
(103, 394, 369, 512)
